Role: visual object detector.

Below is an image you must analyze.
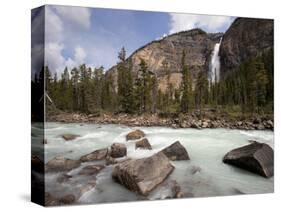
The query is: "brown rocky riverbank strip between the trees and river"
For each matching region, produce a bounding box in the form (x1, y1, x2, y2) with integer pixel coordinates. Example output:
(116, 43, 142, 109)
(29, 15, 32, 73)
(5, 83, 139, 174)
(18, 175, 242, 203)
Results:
(47, 112, 274, 130)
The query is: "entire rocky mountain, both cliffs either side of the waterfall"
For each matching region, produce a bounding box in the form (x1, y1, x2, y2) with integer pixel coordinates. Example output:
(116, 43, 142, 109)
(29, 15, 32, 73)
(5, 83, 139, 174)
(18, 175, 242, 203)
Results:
(107, 18, 273, 91)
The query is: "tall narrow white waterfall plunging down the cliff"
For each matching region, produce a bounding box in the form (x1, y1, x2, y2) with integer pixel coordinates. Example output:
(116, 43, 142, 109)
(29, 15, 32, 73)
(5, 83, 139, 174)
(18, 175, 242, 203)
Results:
(209, 38, 222, 83)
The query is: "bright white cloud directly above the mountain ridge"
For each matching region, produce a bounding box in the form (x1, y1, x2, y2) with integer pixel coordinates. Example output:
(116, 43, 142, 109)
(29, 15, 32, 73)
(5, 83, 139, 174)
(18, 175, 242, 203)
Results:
(169, 13, 233, 34)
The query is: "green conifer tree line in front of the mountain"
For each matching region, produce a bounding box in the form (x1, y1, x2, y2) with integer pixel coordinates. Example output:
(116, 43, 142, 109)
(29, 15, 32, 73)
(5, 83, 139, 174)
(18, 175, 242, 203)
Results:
(33, 48, 273, 114)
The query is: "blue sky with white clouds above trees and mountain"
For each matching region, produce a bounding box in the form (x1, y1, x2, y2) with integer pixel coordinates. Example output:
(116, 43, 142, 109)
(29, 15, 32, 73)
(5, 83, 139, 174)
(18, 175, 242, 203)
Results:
(31, 5, 235, 74)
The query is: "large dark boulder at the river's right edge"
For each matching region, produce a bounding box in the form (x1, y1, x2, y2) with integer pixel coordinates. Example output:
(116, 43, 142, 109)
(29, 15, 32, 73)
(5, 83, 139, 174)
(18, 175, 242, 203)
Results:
(223, 142, 274, 177)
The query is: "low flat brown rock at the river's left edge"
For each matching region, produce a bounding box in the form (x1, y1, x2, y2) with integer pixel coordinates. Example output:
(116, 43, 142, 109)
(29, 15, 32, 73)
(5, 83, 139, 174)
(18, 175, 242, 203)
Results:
(46, 157, 81, 172)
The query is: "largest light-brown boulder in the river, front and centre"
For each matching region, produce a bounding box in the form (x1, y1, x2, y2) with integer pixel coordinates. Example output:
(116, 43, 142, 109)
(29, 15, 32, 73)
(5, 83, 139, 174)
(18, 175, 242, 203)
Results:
(112, 152, 174, 195)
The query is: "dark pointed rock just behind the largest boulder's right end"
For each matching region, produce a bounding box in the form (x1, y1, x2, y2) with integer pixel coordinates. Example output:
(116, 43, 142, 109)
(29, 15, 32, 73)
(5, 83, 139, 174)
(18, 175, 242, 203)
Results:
(161, 141, 190, 160)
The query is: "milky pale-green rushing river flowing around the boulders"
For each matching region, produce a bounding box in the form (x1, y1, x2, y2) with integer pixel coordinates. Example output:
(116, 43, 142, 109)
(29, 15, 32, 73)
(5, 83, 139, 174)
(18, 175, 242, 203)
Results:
(33, 123, 274, 203)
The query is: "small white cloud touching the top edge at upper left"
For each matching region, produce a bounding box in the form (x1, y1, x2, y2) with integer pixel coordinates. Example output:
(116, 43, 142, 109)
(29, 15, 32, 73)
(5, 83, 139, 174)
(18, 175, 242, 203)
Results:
(54, 6, 91, 29)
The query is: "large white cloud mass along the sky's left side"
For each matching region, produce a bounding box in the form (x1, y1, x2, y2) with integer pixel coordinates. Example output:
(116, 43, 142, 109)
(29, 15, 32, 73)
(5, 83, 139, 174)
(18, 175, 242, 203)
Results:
(42, 6, 91, 76)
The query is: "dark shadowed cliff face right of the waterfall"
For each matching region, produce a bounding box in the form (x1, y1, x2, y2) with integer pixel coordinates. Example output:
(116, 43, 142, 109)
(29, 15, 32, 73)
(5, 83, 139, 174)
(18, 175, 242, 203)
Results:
(220, 18, 273, 76)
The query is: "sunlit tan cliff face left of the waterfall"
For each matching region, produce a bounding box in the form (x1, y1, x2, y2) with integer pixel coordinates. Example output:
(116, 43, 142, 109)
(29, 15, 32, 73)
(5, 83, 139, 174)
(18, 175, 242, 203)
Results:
(109, 29, 222, 91)
